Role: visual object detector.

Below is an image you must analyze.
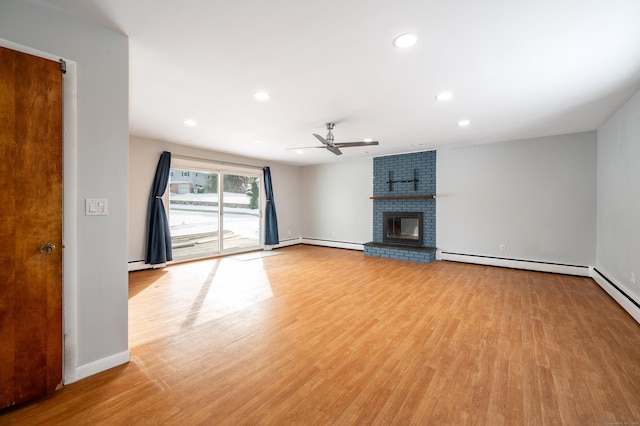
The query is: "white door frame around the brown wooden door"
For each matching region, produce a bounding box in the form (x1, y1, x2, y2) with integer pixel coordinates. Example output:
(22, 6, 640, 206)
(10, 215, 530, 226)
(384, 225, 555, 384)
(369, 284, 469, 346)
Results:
(0, 38, 82, 384)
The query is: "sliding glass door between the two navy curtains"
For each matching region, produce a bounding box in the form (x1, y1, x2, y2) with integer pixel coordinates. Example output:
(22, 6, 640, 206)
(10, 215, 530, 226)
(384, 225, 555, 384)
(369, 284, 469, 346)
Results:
(167, 159, 262, 260)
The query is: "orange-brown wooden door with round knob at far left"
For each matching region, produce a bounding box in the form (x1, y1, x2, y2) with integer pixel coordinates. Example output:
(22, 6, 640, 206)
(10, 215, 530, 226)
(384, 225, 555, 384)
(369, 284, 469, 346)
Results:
(0, 47, 62, 409)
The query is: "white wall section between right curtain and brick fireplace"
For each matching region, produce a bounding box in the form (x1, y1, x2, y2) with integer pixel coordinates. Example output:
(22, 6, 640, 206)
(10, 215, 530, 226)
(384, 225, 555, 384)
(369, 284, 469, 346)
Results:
(300, 158, 373, 244)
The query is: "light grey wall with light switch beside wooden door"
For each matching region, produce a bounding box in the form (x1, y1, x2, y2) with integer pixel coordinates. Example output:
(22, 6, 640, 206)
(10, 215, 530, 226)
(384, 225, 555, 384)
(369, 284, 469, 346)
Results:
(0, 0, 129, 382)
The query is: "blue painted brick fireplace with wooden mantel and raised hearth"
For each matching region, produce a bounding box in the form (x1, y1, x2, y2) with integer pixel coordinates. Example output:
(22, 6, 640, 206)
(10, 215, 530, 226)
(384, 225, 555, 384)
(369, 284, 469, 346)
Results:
(364, 151, 436, 263)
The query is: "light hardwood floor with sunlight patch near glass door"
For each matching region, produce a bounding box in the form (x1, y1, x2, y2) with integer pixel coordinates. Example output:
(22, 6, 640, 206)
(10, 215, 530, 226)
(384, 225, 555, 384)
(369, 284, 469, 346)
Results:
(0, 246, 640, 425)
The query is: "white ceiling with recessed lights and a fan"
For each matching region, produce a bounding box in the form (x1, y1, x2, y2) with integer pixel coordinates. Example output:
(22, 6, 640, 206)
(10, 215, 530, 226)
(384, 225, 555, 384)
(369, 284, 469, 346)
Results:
(33, 0, 640, 165)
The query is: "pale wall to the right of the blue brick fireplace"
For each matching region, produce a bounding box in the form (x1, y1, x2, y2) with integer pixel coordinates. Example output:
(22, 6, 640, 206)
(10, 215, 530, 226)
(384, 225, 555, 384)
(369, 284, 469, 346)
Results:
(436, 132, 596, 266)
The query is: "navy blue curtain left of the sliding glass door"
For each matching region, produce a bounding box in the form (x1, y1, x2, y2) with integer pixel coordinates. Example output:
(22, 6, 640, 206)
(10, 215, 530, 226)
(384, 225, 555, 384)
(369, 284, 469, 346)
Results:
(144, 151, 173, 265)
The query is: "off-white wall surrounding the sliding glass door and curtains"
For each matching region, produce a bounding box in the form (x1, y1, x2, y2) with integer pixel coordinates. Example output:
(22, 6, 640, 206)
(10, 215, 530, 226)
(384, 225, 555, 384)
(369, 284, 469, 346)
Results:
(129, 135, 301, 262)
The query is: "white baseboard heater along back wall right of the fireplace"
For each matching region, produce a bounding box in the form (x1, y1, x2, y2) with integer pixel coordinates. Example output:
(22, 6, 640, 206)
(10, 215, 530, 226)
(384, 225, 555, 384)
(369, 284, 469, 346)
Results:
(436, 251, 591, 277)
